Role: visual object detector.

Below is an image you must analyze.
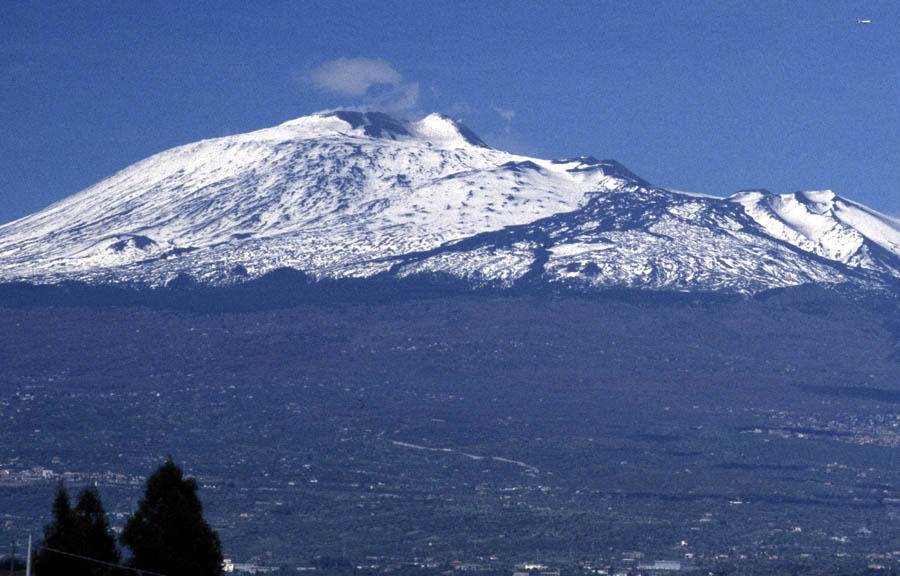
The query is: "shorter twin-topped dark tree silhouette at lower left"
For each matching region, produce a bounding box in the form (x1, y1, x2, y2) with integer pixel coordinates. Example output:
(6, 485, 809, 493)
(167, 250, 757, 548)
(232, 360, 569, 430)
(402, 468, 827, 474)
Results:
(34, 484, 119, 576)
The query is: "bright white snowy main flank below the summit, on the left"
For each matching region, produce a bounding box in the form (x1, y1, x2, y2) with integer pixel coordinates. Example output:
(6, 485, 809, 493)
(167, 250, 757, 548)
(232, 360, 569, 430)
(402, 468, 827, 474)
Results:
(0, 112, 618, 283)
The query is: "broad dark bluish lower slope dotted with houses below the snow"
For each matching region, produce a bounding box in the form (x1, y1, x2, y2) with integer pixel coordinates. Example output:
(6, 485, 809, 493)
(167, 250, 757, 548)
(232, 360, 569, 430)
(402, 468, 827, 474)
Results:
(0, 291, 900, 566)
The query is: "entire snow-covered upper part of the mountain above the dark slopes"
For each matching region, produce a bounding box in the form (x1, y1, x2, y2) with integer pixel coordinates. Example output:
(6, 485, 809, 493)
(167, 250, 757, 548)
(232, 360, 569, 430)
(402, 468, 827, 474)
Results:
(0, 112, 900, 292)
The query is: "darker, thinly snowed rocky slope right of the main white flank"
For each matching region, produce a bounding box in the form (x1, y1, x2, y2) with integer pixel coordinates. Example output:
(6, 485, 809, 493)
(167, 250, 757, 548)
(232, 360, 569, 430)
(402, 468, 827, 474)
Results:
(400, 186, 864, 293)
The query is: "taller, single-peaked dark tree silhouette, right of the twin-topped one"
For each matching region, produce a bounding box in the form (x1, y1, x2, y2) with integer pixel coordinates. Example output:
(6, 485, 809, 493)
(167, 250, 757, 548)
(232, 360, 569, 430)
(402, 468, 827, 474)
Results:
(120, 458, 222, 576)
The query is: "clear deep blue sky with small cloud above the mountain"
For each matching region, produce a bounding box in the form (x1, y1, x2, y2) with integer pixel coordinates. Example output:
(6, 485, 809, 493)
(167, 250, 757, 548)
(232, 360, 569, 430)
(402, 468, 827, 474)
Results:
(0, 0, 900, 222)
